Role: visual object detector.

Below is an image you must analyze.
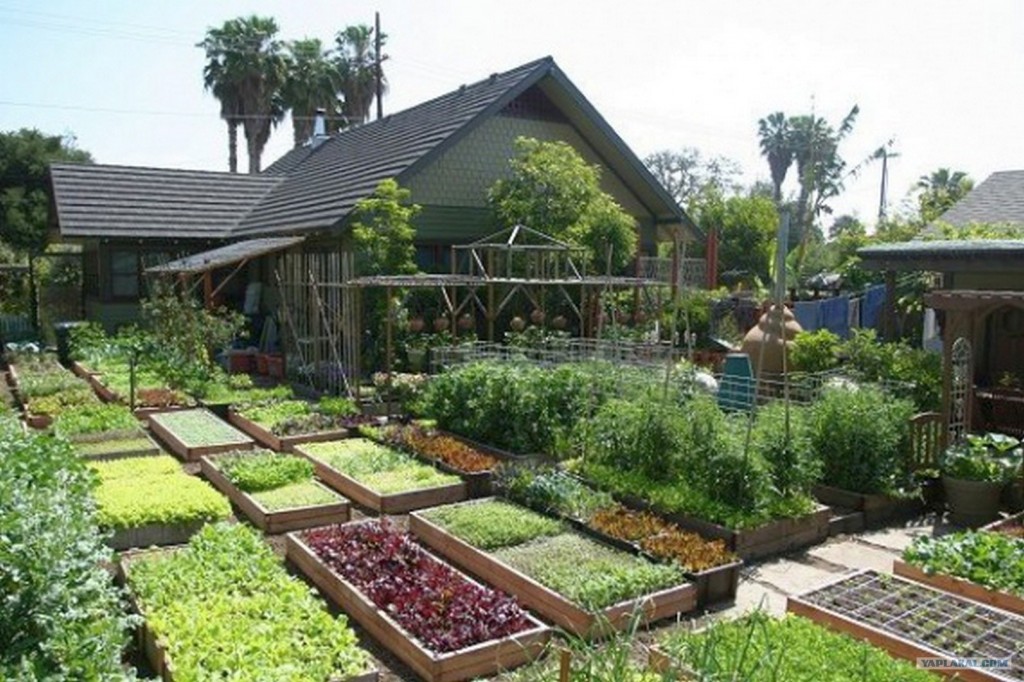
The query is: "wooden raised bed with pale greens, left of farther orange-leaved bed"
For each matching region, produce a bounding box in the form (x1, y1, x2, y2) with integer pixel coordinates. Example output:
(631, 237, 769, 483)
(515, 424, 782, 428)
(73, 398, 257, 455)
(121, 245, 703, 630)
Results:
(295, 438, 468, 514)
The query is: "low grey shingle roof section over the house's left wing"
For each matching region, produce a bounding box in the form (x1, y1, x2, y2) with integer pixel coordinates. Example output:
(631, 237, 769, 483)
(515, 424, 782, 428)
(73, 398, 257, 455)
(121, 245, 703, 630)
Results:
(50, 164, 282, 239)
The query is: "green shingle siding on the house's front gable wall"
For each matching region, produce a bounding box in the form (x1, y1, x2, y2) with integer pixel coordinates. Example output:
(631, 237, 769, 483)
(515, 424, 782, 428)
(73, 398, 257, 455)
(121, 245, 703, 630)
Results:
(402, 111, 649, 218)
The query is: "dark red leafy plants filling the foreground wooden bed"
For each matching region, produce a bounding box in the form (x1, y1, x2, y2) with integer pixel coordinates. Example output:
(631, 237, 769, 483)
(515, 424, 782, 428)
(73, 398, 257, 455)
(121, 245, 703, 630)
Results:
(301, 520, 532, 653)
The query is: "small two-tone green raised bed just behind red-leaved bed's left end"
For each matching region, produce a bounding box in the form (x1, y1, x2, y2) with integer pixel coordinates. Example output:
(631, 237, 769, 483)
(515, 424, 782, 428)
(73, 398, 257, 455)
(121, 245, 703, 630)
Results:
(200, 451, 350, 534)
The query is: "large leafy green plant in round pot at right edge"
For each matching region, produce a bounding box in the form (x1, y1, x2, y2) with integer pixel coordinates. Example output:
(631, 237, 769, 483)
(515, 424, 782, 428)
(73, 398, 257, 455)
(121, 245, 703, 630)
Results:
(941, 433, 1024, 526)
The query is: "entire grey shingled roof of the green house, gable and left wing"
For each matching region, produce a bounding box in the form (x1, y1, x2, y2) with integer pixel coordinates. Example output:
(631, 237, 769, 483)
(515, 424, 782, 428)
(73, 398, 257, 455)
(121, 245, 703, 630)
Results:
(53, 57, 697, 239)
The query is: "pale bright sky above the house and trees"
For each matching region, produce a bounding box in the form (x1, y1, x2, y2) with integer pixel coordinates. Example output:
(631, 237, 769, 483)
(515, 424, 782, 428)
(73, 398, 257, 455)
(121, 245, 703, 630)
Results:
(0, 0, 1024, 228)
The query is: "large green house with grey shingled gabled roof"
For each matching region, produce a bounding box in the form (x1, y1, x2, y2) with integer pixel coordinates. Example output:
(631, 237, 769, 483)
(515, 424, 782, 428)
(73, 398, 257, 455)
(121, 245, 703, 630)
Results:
(51, 57, 699, 327)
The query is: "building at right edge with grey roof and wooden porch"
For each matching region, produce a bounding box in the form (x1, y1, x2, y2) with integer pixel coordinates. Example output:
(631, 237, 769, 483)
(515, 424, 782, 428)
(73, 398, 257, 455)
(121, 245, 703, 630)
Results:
(858, 166, 1024, 439)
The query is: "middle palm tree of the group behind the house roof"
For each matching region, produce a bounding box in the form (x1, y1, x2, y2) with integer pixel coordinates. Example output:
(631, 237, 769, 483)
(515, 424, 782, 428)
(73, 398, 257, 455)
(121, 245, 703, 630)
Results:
(282, 38, 341, 146)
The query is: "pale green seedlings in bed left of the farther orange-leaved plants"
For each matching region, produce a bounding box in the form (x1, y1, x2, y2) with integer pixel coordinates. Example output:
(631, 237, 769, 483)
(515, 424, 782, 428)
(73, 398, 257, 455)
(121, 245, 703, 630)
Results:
(300, 438, 462, 495)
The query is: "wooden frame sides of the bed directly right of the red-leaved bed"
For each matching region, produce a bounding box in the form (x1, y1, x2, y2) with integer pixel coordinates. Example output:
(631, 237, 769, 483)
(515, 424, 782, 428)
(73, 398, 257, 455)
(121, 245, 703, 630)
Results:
(409, 513, 697, 638)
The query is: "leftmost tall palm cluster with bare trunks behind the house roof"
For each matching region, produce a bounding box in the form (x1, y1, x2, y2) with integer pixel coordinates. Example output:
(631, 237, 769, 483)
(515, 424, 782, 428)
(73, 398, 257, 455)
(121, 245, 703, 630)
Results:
(199, 15, 288, 173)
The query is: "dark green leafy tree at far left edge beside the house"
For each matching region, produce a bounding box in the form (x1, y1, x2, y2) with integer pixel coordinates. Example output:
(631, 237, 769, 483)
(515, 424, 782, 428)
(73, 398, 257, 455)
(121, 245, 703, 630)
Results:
(0, 128, 92, 254)
